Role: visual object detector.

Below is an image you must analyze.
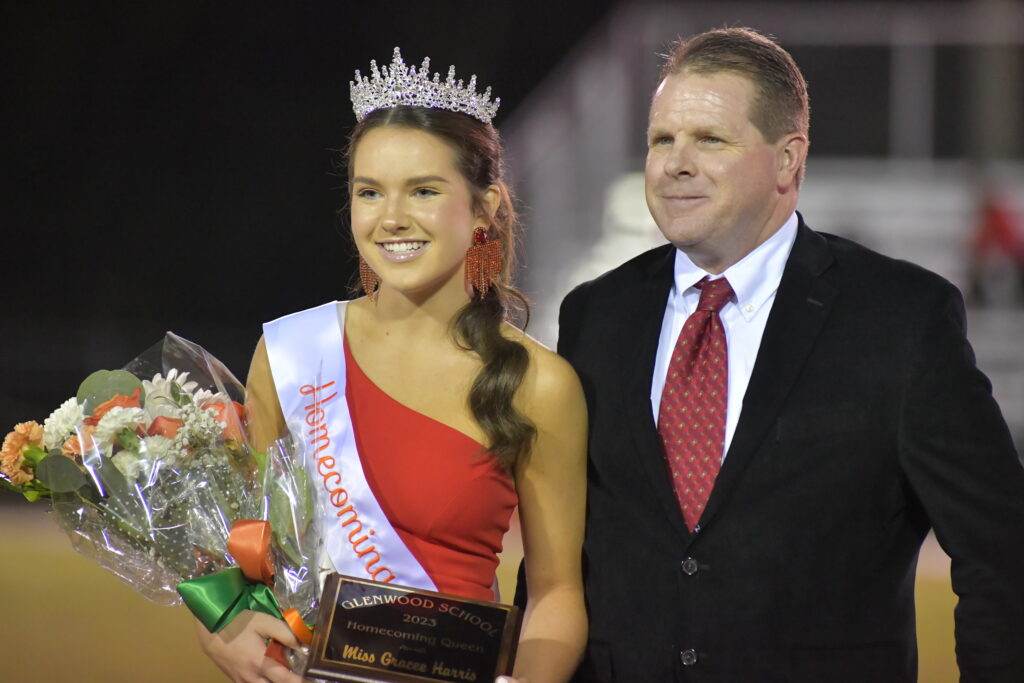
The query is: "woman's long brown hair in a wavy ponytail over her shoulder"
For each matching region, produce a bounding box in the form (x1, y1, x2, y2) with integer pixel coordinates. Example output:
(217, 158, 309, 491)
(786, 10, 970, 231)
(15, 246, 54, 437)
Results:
(345, 106, 537, 472)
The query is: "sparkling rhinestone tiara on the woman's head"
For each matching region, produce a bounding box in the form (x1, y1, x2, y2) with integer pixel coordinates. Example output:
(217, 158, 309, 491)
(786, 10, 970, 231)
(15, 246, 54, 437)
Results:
(348, 47, 502, 123)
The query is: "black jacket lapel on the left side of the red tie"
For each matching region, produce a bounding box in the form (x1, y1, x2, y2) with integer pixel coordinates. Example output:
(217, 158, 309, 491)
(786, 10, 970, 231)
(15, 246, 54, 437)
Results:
(618, 245, 689, 539)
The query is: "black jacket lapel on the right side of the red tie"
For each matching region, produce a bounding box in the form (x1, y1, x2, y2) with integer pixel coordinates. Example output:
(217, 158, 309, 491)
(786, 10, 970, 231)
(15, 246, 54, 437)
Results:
(700, 218, 837, 526)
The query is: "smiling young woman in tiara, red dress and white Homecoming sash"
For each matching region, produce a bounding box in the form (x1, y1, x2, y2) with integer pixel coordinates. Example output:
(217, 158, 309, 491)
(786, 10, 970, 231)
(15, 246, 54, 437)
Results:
(200, 50, 587, 683)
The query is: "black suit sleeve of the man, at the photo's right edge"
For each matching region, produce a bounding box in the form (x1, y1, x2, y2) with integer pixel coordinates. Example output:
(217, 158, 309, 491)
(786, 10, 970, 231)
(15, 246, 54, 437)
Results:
(899, 284, 1024, 683)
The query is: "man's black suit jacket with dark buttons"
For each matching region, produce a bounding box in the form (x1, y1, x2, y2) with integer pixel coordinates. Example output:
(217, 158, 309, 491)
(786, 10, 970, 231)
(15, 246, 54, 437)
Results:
(558, 220, 1024, 683)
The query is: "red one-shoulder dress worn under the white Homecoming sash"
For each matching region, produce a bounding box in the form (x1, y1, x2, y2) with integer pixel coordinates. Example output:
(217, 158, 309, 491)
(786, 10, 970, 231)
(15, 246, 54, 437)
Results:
(345, 341, 518, 600)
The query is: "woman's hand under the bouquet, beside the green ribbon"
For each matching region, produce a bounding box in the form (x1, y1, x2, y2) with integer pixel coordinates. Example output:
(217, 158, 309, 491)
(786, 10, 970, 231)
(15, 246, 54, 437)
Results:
(196, 609, 302, 683)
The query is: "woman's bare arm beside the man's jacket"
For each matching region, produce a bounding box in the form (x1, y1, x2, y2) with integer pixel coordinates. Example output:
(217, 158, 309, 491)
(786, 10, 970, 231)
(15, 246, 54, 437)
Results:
(515, 342, 587, 683)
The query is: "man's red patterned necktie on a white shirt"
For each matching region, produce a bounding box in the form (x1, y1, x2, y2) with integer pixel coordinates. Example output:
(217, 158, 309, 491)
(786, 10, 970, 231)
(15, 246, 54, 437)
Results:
(657, 278, 732, 531)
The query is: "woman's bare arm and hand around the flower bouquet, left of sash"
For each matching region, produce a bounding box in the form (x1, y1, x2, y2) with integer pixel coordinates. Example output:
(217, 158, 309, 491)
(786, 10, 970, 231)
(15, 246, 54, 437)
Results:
(196, 339, 302, 683)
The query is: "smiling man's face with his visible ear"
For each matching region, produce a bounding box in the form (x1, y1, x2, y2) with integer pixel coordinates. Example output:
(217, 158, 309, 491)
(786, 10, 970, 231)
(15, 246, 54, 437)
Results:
(644, 71, 796, 272)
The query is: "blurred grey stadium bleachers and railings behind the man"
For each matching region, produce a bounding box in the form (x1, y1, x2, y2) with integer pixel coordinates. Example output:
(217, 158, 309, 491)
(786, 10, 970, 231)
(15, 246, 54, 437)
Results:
(503, 0, 1024, 450)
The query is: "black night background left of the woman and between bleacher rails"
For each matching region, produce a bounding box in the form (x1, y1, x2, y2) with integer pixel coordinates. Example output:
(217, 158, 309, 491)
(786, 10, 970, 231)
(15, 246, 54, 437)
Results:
(0, 0, 1007, 481)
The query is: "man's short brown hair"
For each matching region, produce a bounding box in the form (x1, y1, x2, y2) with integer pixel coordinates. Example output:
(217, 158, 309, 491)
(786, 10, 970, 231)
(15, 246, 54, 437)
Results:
(659, 29, 810, 142)
